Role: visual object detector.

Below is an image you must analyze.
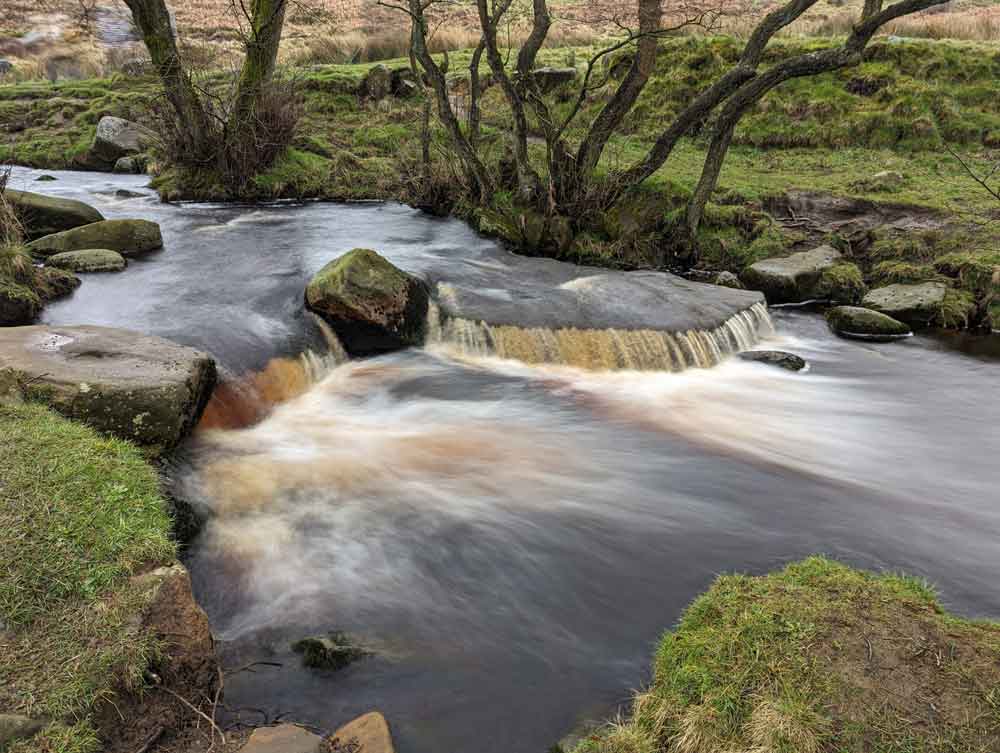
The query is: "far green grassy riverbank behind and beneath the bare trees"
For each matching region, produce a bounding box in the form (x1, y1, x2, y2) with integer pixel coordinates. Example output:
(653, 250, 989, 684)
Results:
(0, 37, 1000, 329)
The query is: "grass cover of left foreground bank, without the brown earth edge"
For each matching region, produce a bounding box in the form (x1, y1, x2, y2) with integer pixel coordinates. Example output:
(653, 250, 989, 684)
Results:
(0, 404, 175, 753)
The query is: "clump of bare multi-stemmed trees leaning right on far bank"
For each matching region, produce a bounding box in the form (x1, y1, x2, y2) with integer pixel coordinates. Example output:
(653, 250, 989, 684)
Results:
(395, 0, 947, 262)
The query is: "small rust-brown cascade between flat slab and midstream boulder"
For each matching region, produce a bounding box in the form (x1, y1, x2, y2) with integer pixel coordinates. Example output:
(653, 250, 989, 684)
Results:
(198, 313, 348, 429)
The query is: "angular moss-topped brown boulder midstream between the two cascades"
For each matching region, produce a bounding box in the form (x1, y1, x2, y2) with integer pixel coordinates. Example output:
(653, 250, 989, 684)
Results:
(305, 248, 429, 355)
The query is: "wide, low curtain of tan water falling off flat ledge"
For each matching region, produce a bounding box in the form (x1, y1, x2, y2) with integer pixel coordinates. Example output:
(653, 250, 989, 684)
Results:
(427, 303, 773, 371)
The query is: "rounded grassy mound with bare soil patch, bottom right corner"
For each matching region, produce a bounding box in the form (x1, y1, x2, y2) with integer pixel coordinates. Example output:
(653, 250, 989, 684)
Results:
(576, 557, 1000, 753)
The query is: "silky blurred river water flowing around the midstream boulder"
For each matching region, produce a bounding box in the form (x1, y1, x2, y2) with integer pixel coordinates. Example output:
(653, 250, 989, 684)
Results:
(9, 171, 1000, 753)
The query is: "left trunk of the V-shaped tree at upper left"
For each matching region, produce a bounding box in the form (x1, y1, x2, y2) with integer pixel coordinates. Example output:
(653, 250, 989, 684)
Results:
(125, 0, 213, 160)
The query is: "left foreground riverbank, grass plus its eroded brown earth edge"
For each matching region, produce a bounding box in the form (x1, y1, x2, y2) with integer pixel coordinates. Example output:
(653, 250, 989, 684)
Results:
(0, 403, 218, 753)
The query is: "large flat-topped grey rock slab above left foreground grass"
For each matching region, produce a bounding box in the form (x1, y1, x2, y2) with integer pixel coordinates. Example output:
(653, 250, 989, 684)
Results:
(0, 325, 216, 455)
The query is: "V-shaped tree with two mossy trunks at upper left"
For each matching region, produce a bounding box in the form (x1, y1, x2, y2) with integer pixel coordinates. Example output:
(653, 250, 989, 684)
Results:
(125, 0, 294, 189)
